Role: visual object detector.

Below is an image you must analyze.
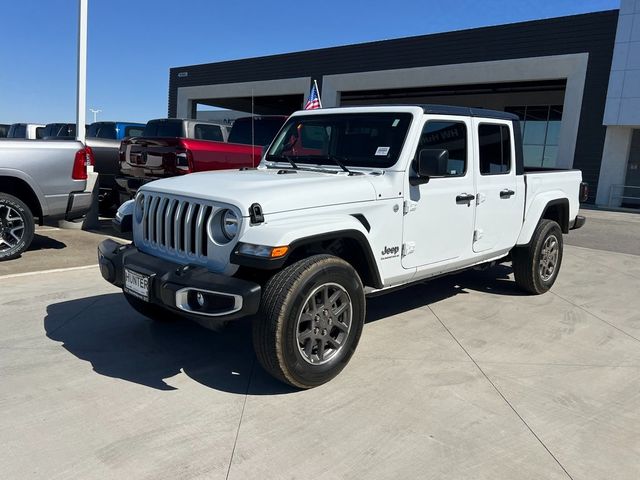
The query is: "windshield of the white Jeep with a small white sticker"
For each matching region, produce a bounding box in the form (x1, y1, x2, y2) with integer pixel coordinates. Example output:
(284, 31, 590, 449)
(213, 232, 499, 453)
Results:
(266, 112, 412, 168)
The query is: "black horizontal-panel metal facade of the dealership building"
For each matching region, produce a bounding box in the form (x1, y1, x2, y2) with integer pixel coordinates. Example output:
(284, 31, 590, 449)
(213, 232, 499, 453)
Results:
(169, 10, 618, 202)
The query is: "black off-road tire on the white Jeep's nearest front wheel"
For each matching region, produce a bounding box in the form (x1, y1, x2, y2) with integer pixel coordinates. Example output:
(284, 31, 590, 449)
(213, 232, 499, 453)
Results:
(253, 255, 366, 388)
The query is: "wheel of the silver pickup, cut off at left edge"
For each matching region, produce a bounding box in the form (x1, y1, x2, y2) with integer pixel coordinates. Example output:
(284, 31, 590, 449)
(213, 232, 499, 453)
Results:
(0, 193, 36, 262)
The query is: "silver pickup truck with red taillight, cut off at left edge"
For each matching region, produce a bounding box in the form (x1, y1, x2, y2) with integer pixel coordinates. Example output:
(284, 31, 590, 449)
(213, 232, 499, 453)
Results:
(0, 140, 93, 261)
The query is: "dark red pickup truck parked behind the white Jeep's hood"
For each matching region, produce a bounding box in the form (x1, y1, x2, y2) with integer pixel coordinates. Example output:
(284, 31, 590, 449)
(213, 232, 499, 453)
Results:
(116, 116, 287, 202)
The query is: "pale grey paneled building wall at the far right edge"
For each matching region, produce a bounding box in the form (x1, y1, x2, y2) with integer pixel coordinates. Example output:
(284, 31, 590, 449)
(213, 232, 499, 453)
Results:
(596, 0, 640, 207)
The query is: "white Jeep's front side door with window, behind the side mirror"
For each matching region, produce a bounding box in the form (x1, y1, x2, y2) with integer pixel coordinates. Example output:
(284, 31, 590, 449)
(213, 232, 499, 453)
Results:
(402, 116, 475, 269)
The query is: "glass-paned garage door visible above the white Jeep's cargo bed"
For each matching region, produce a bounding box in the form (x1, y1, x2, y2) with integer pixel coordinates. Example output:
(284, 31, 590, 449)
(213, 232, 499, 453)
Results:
(505, 105, 562, 167)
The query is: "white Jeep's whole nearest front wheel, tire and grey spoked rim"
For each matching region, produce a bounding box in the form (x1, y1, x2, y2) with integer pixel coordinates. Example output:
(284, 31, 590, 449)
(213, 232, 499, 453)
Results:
(253, 255, 365, 388)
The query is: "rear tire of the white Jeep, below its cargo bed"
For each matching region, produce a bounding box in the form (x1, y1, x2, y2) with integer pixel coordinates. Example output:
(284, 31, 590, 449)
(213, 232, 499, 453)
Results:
(511, 219, 563, 295)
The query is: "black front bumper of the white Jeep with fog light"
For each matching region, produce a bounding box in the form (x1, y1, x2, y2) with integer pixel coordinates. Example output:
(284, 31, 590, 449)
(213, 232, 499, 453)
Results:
(98, 239, 261, 329)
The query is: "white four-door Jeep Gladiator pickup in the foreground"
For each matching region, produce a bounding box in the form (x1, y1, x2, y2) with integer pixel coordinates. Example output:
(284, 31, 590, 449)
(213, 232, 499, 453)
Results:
(99, 105, 586, 388)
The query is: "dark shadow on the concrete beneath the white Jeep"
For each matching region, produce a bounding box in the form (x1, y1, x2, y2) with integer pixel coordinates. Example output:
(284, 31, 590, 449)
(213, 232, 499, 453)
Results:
(44, 266, 520, 395)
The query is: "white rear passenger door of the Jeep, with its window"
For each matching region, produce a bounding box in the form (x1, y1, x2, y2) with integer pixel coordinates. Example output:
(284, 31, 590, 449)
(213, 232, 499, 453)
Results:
(473, 118, 525, 253)
